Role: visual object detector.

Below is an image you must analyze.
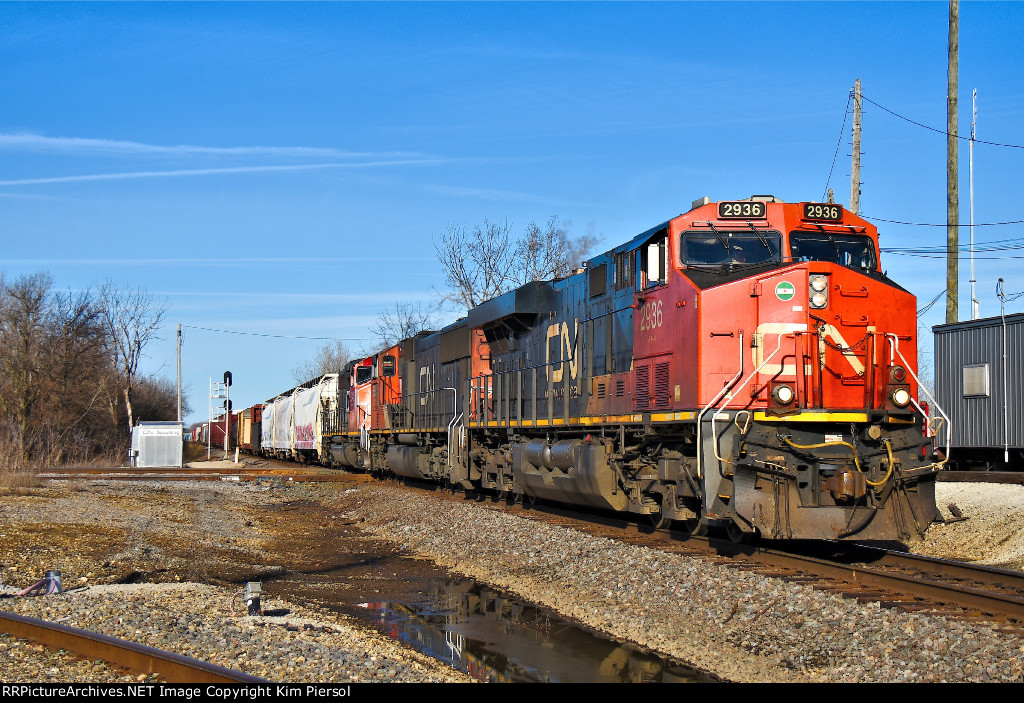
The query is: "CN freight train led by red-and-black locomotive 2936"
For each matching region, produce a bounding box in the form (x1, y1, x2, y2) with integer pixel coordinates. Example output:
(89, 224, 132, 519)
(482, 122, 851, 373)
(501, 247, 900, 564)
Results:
(235, 195, 949, 541)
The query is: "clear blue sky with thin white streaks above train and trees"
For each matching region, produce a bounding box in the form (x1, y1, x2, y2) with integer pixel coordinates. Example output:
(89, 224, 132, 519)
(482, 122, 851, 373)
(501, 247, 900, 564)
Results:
(0, 2, 1024, 421)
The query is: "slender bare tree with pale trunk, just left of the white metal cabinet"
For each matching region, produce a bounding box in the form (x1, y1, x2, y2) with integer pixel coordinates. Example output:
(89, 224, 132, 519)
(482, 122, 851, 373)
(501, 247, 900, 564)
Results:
(99, 280, 167, 431)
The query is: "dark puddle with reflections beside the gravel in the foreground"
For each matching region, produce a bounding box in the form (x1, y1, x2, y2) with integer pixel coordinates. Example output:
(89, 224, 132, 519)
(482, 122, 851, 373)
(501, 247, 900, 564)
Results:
(359, 580, 714, 683)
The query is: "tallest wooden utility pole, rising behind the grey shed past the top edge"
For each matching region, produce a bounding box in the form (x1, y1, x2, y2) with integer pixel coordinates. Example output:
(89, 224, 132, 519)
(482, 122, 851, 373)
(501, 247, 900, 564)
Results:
(946, 0, 959, 324)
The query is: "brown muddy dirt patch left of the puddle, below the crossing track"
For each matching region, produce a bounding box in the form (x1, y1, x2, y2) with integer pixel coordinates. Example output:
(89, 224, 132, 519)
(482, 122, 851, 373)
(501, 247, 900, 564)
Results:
(0, 475, 458, 612)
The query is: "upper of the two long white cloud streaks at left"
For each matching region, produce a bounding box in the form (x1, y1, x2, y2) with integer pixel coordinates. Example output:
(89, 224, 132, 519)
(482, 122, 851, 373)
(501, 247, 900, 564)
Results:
(0, 134, 427, 159)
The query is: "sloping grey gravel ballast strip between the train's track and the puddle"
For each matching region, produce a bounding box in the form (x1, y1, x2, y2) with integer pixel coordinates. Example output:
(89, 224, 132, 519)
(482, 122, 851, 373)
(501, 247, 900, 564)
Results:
(337, 486, 1024, 682)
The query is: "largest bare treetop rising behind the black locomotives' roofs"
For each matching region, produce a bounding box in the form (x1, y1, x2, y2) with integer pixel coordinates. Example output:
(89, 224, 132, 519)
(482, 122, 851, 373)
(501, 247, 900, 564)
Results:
(434, 216, 599, 309)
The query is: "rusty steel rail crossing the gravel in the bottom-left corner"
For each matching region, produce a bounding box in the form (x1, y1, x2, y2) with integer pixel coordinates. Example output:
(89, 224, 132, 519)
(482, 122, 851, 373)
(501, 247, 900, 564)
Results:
(0, 611, 270, 684)
